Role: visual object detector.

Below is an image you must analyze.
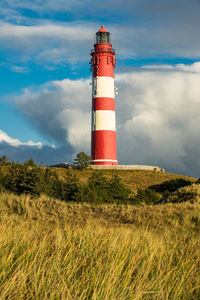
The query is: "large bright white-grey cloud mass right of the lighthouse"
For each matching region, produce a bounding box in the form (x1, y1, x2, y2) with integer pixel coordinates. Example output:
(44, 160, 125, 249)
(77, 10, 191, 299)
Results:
(118, 63, 200, 176)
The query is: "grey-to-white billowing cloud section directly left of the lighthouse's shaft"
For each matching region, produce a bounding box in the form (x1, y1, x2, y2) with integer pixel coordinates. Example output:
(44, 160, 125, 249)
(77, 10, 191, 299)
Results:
(15, 79, 91, 151)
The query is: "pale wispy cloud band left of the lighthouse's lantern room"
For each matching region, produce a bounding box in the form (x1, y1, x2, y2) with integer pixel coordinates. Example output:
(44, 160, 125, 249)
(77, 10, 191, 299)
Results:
(0, 21, 95, 65)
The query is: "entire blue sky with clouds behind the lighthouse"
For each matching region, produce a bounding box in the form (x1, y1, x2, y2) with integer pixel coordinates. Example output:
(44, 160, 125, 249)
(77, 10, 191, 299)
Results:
(0, 0, 200, 177)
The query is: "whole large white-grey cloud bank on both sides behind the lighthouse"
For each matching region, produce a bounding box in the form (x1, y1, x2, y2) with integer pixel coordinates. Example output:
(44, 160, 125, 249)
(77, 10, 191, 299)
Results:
(1, 63, 200, 177)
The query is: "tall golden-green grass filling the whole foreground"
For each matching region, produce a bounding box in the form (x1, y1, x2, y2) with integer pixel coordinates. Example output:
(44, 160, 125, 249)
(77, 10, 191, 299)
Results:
(0, 194, 200, 300)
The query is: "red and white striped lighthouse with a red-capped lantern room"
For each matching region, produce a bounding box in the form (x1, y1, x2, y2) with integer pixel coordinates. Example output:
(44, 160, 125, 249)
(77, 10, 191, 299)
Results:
(90, 25, 118, 165)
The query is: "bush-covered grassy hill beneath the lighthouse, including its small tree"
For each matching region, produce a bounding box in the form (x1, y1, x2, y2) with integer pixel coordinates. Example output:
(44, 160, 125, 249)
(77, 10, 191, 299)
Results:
(0, 156, 198, 205)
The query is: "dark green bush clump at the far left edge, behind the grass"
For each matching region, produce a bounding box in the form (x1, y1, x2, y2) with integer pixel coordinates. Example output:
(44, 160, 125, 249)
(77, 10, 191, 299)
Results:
(0, 159, 78, 201)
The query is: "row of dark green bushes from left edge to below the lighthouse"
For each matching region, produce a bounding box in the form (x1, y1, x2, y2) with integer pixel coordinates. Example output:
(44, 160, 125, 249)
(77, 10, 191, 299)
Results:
(0, 159, 130, 204)
